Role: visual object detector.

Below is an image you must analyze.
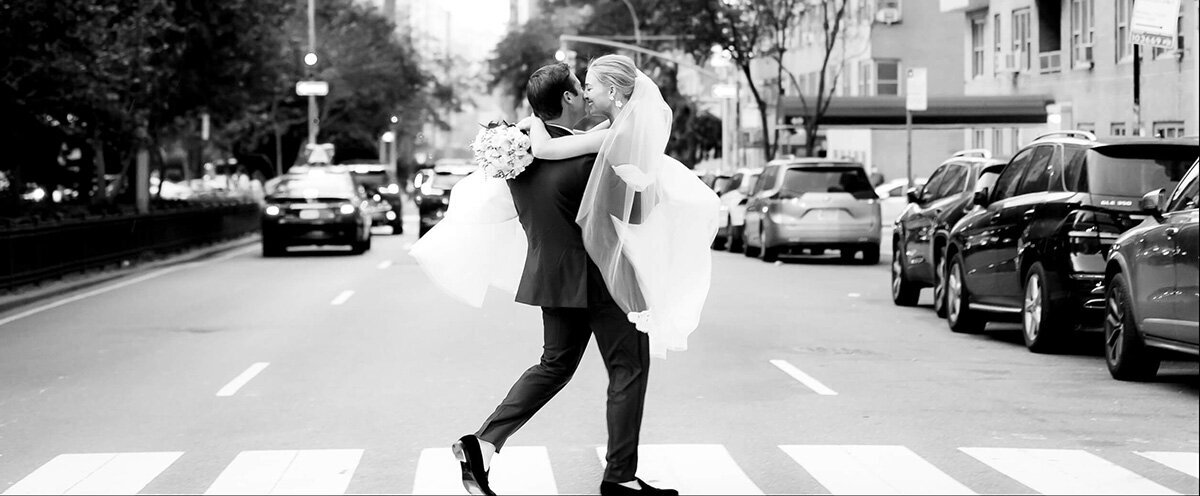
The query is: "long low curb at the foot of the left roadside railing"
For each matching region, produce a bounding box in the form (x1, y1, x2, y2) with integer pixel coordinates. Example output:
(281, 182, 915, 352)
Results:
(0, 233, 259, 313)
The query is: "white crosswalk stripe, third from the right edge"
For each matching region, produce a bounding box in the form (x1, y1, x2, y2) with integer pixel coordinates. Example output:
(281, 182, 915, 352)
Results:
(780, 446, 974, 495)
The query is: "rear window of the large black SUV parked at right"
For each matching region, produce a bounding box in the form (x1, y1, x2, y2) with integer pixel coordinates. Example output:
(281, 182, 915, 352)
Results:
(1064, 145, 1198, 198)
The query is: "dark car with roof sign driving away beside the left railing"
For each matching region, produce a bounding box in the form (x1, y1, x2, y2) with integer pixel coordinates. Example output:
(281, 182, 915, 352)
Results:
(262, 169, 371, 257)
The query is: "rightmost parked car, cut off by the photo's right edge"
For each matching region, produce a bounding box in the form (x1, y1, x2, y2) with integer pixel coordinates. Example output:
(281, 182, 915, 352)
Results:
(1104, 158, 1200, 381)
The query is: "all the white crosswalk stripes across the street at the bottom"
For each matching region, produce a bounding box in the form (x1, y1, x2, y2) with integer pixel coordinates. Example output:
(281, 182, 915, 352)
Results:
(0, 444, 1200, 495)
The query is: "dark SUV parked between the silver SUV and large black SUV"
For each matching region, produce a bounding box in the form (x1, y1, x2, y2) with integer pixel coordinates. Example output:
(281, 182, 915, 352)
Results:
(892, 150, 1008, 317)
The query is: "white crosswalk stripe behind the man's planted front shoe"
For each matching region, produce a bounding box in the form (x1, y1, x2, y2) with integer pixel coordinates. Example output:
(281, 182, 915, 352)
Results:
(596, 444, 762, 495)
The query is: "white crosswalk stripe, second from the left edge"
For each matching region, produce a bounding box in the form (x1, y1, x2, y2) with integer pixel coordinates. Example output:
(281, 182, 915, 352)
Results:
(204, 449, 362, 495)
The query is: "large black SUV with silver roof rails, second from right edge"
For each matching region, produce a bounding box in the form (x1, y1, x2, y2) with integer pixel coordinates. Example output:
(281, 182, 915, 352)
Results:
(946, 131, 1200, 353)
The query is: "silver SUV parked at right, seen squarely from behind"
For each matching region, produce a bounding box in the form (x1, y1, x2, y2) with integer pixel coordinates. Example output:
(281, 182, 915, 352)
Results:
(742, 159, 881, 264)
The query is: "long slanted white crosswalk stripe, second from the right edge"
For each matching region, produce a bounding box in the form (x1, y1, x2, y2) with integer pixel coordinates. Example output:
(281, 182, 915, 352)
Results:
(960, 448, 1177, 495)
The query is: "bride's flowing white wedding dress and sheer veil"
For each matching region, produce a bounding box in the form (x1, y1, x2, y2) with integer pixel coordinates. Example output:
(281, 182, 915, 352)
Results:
(410, 73, 720, 358)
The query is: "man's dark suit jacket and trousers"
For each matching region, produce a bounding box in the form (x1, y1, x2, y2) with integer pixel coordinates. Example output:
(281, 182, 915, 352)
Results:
(476, 126, 650, 483)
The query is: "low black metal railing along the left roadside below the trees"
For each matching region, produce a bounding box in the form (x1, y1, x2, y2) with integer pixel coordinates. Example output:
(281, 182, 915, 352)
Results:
(0, 203, 259, 289)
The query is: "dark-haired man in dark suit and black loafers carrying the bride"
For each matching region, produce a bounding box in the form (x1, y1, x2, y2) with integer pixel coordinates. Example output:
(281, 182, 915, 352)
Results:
(452, 64, 678, 496)
